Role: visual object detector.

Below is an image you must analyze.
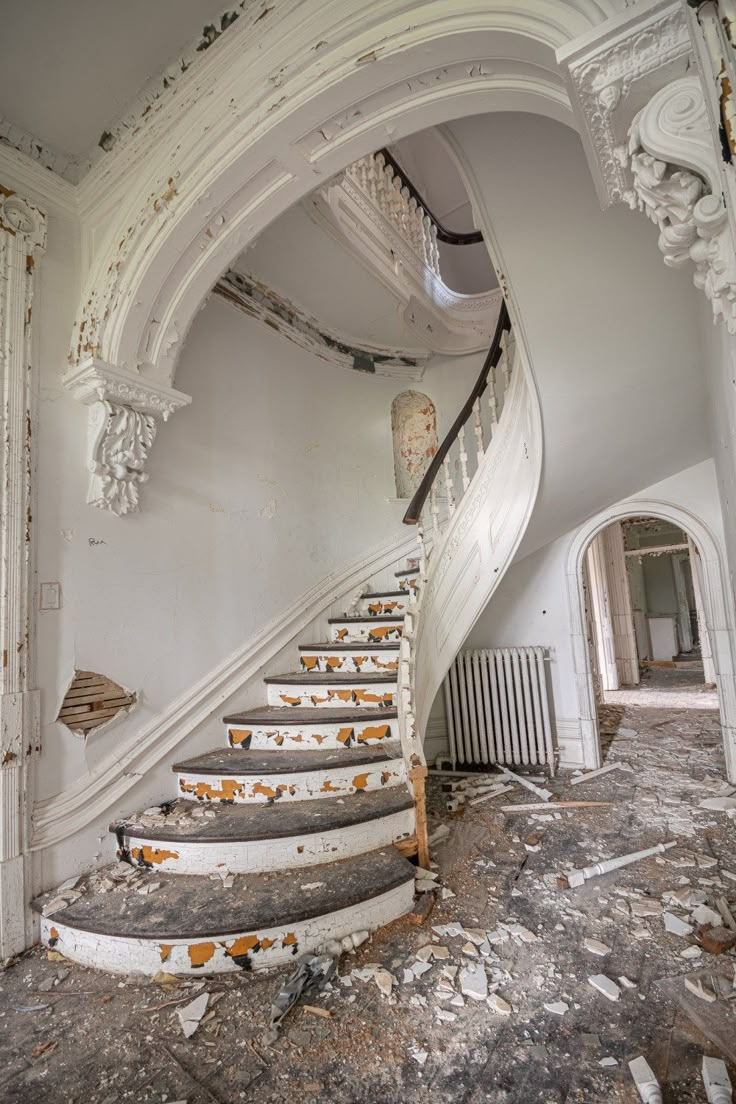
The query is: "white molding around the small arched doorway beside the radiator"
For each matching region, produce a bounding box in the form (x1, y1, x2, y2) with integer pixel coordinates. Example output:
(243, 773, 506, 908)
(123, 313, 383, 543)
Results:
(565, 498, 736, 783)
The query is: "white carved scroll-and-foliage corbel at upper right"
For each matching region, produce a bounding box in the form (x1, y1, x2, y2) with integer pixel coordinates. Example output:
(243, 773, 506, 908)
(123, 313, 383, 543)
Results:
(625, 76, 736, 333)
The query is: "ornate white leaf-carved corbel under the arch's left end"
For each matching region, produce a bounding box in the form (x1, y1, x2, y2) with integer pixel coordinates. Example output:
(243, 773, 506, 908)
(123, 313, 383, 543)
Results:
(64, 358, 191, 517)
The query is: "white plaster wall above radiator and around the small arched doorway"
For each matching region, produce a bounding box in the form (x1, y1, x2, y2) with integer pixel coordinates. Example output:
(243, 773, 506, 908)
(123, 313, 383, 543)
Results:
(463, 460, 725, 739)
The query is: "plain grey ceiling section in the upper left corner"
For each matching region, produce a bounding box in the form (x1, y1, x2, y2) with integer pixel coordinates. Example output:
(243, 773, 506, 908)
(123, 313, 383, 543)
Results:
(0, 0, 226, 158)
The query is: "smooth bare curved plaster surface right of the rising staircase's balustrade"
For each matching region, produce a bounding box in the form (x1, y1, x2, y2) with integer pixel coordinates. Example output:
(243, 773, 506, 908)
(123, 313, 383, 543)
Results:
(449, 114, 712, 554)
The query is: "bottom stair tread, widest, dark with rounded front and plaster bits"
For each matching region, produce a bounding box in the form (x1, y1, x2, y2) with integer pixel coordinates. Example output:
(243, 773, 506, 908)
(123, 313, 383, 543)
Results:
(34, 847, 414, 940)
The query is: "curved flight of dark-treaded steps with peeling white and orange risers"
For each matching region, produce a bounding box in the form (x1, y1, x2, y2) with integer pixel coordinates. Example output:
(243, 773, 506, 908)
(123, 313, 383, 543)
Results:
(35, 569, 418, 975)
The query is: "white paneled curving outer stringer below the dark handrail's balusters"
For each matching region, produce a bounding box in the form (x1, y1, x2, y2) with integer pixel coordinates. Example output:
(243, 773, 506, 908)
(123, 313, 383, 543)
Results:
(408, 340, 543, 743)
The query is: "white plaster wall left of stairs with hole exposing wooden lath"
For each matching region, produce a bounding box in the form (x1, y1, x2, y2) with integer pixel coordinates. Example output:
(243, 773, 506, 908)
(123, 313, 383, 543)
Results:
(38, 280, 482, 884)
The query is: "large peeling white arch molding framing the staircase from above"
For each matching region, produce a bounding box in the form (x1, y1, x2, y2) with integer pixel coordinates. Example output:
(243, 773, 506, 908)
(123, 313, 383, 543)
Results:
(59, 0, 621, 512)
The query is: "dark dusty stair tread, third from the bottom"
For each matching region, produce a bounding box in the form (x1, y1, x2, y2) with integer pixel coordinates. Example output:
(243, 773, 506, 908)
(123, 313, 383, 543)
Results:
(172, 744, 402, 776)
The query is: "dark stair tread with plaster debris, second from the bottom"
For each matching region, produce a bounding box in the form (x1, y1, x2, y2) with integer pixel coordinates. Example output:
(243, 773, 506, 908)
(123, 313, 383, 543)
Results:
(110, 787, 414, 843)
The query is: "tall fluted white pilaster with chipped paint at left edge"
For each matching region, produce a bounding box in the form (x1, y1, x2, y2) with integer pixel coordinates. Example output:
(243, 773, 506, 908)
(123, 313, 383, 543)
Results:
(0, 184, 46, 958)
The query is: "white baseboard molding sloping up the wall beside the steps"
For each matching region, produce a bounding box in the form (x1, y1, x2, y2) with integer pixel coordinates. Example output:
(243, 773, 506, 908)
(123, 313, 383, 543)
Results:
(31, 531, 416, 851)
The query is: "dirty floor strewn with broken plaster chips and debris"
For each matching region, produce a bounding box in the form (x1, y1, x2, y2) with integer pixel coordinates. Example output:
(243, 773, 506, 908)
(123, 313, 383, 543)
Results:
(0, 693, 736, 1104)
